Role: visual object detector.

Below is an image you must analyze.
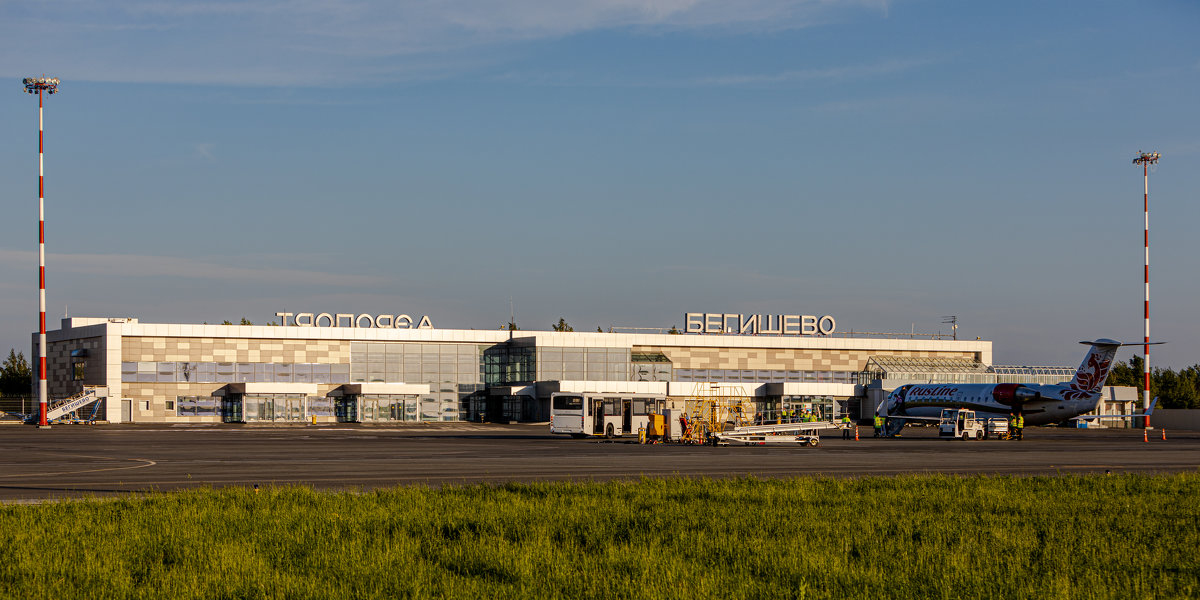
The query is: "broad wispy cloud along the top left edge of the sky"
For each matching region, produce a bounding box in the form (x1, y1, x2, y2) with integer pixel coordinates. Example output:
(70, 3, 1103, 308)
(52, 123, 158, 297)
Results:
(0, 0, 887, 86)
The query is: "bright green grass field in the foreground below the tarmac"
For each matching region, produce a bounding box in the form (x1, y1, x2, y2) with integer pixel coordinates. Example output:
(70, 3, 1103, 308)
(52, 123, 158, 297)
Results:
(0, 474, 1200, 599)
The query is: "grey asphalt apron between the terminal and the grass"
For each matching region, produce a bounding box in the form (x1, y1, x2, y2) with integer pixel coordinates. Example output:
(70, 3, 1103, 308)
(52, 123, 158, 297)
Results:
(0, 424, 1200, 502)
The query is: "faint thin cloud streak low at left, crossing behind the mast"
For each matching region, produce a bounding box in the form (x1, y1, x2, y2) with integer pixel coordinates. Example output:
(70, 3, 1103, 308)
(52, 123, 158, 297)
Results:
(0, 250, 388, 287)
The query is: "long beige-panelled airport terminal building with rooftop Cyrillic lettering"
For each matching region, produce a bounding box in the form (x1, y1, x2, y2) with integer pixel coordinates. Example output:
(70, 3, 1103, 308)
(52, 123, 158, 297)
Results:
(34, 312, 1003, 424)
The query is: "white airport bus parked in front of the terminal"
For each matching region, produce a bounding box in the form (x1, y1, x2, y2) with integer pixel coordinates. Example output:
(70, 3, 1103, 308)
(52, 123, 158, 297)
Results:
(550, 391, 667, 438)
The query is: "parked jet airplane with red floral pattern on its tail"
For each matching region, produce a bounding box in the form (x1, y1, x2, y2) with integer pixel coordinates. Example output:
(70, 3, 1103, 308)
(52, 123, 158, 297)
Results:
(876, 338, 1163, 437)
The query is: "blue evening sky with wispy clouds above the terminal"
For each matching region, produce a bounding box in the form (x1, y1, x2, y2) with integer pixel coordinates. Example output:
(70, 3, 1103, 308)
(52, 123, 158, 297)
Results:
(0, 0, 1200, 368)
